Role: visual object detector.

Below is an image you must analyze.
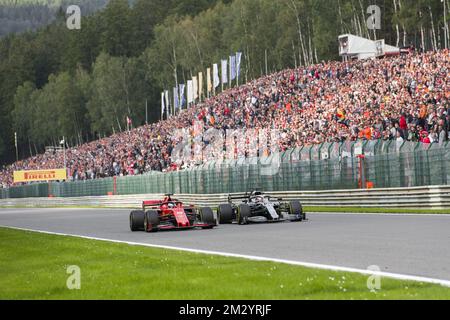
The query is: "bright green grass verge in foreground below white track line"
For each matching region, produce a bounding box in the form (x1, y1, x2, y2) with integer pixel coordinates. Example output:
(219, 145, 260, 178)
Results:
(0, 228, 450, 300)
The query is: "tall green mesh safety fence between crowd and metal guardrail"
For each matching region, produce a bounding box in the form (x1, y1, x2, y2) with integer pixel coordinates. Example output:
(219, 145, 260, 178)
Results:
(0, 140, 450, 199)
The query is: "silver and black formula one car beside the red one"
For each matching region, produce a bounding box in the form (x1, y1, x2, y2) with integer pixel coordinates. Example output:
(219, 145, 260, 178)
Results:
(217, 191, 306, 225)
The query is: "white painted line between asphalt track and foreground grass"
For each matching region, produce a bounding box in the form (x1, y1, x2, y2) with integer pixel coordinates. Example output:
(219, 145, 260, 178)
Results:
(0, 226, 450, 287)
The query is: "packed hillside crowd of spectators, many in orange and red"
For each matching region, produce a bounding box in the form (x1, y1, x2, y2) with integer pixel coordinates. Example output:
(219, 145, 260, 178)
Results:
(0, 50, 450, 188)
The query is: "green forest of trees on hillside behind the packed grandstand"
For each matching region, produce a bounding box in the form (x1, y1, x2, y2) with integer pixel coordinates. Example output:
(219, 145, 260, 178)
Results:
(0, 0, 450, 163)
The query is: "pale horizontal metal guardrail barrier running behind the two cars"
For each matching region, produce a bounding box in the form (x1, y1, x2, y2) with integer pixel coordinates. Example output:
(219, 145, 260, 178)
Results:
(0, 186, 450, 209)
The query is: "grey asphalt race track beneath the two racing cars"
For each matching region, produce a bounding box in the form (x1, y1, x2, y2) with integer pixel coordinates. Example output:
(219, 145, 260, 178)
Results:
(0, 209, 450, 280)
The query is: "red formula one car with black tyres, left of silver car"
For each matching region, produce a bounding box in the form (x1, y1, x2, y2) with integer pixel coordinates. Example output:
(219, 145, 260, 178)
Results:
(130, 194, 217, 232)
